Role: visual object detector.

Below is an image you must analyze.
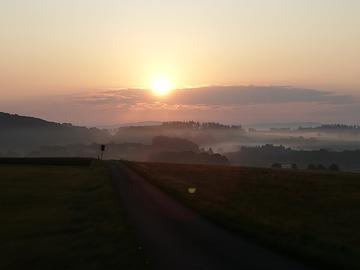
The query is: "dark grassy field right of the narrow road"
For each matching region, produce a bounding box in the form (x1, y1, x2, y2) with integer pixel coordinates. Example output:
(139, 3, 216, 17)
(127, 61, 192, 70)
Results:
(128, 163, 360, 269)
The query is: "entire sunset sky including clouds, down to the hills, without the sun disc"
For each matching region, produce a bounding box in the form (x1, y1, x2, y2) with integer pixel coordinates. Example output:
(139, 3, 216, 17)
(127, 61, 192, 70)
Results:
(0, 0, 360, 125)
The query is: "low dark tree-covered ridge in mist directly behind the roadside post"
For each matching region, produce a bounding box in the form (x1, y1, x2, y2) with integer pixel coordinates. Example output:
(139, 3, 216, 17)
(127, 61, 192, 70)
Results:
(29, 136, 229, 165)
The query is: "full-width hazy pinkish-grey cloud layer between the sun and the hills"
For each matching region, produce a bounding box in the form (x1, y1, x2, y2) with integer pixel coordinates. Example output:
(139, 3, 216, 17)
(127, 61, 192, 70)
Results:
(0, 86, 360, 126)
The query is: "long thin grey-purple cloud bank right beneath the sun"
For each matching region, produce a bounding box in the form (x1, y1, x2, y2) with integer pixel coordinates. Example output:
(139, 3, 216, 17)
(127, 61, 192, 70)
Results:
(74, 86, 355, 108)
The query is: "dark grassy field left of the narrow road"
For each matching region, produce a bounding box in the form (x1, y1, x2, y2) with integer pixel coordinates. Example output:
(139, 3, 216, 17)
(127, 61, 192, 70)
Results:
(0, 161, 144, 270)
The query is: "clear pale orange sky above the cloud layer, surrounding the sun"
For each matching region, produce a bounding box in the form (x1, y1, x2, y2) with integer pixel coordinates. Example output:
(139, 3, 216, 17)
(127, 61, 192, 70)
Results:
(0, 0, 360, 121)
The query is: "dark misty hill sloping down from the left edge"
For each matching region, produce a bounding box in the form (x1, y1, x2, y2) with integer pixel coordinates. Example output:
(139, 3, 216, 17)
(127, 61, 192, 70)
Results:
(0, 112, 110, 156)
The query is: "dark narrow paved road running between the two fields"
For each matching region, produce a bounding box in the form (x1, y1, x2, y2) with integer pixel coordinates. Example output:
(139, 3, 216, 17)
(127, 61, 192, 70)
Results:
(110, 162, 310, 270)
